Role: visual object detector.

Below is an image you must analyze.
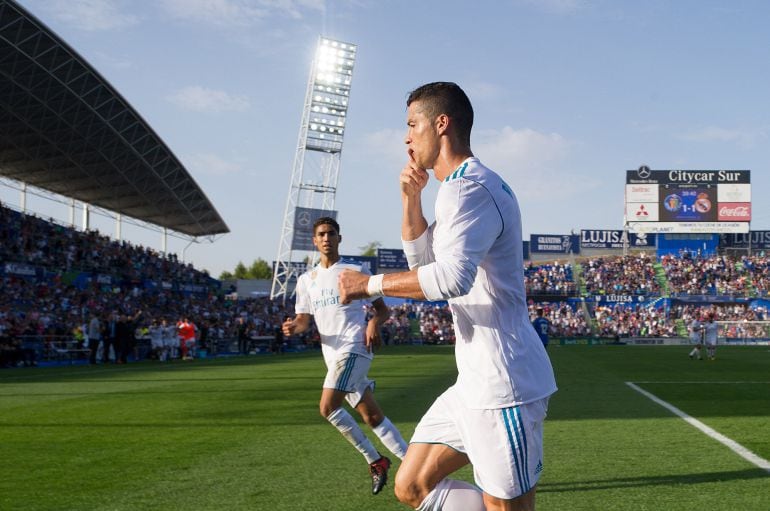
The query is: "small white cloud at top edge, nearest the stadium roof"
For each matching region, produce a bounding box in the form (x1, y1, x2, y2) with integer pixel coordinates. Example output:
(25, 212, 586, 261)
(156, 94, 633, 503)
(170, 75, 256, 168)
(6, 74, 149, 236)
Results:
(49, 0, 139, 32)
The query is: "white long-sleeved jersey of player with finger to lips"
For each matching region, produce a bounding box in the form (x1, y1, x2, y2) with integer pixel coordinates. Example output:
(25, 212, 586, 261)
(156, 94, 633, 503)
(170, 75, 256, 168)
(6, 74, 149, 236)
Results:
(403, 158, 556, 408)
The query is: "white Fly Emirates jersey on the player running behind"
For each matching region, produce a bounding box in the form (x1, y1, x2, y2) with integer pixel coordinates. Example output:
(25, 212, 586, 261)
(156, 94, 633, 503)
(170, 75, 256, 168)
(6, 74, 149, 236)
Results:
(294, 259, 372, 365)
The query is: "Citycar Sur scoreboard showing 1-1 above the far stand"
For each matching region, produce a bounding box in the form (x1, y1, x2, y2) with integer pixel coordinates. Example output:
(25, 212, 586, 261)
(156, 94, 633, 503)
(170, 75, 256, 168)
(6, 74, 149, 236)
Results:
(625, 167, 751, 234)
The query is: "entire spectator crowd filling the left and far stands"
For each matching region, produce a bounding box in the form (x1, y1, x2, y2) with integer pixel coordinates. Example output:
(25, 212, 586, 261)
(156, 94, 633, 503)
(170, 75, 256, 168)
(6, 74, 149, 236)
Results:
(0, 206, 770, 366)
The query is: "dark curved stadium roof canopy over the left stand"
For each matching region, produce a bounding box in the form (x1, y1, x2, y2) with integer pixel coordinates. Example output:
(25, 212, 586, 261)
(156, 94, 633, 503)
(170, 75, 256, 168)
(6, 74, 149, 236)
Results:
(0, 0, 229, 236)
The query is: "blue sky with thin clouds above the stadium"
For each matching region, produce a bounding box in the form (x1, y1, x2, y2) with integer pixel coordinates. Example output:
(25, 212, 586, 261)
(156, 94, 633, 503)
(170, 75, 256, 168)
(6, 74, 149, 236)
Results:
(0, 0, 770, 276)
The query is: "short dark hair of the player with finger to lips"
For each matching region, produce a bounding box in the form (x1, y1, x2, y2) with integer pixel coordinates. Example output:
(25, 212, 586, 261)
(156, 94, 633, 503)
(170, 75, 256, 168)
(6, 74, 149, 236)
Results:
(406, 82, 473, 146)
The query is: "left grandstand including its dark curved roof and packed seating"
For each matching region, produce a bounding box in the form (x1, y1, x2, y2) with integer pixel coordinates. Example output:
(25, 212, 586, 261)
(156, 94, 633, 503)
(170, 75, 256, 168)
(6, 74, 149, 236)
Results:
(0, 0, 236, 366)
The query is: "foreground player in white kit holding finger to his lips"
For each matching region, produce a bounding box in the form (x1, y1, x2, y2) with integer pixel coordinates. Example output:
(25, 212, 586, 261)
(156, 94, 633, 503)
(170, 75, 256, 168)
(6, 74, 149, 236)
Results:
(340, 82, 556, 511)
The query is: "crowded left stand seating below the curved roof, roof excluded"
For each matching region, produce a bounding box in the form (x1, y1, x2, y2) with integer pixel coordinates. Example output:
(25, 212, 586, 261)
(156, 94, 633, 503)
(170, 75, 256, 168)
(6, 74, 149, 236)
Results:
(0, 202, 290, 366)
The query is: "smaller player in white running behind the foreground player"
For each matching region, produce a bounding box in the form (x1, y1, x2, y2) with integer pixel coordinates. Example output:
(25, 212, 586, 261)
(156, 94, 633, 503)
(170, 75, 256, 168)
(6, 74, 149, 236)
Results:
(283, 217, 407, 495)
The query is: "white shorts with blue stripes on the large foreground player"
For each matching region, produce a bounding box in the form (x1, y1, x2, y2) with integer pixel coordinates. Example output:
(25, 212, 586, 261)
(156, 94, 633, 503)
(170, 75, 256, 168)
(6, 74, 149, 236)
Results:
(410, 387, 548, 499)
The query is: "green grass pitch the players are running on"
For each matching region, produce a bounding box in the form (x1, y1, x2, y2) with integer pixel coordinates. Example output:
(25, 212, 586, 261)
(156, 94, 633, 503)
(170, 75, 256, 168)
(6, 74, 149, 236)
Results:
(0, 346, 770, 511)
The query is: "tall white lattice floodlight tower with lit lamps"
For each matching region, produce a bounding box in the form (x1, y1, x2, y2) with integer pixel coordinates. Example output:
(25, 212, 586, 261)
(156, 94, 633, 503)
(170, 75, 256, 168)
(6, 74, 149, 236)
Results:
(270, 37, 356, 300)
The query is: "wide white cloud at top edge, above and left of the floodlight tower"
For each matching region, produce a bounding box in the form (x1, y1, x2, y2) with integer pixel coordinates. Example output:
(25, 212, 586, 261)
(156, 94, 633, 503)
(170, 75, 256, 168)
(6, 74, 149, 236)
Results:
(161, 0, 324, 27)
